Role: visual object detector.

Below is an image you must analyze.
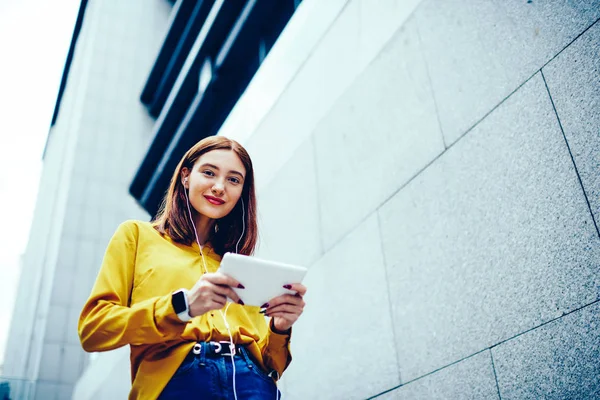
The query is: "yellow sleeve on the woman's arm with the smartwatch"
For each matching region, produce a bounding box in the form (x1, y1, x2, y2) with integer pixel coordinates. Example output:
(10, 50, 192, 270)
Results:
(78, 222, 185, 352)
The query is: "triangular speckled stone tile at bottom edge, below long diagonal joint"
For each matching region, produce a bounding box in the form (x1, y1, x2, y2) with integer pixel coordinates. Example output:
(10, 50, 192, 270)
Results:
(376, 350, 499, 400)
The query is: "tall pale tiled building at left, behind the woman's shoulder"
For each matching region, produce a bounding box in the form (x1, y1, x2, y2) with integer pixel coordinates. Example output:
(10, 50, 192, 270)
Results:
(3, 0, 172, 400)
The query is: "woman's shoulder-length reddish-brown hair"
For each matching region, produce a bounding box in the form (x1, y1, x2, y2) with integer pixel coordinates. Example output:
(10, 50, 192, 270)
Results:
(152, 136, 258, 256)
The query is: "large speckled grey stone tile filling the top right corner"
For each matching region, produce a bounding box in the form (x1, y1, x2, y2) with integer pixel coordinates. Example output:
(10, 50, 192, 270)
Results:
(415, 0, 600, 143)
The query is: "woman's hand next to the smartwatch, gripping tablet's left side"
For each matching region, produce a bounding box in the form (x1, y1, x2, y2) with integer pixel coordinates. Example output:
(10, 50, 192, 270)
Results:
(188, 272, 244, 317)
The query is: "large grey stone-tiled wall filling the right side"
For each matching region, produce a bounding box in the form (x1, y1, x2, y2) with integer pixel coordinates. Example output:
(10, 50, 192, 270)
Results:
(249, 0, 600, 399)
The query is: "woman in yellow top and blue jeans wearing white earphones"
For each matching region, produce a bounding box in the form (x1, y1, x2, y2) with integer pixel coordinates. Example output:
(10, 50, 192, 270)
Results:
(79, 137, 306, 400)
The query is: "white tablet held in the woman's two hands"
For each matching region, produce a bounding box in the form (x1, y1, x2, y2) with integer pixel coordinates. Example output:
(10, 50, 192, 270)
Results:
(219, 253, 308, 307)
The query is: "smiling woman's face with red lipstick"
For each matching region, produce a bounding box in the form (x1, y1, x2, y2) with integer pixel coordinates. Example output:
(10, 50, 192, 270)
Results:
(181, 150, 246, 219)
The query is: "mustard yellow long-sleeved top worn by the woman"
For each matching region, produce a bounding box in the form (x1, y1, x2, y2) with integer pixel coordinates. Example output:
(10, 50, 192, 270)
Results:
(79, 221, 291, 399)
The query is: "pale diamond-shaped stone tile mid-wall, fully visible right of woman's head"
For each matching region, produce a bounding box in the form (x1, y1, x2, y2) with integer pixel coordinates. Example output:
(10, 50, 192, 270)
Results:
(314, 21, 444, 250)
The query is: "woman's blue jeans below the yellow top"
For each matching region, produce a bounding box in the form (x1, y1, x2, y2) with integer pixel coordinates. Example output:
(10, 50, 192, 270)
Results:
(159, 343, 280, 400)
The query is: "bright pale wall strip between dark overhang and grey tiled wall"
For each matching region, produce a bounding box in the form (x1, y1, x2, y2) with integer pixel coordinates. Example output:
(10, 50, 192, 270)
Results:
(241, 0, 421, 189)
